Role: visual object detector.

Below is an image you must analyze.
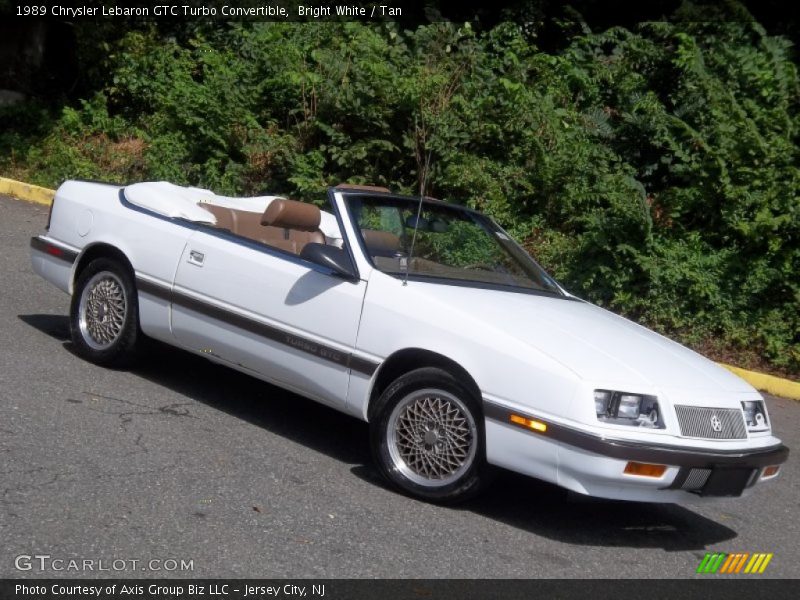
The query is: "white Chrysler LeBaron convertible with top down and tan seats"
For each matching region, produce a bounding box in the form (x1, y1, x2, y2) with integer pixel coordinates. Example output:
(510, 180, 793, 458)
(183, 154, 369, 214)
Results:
(31, 181, 788, 502)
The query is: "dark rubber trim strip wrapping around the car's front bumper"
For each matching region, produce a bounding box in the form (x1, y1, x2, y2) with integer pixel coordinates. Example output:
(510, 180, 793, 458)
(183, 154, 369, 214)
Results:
(483, 400, 789, 469)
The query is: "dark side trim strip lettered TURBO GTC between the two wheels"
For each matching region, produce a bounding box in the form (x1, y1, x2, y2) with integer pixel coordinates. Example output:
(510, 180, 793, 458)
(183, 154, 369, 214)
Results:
(136, 277, 379, 375)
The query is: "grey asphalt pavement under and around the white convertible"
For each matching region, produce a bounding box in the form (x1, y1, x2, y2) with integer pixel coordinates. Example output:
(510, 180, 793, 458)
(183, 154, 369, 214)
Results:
(0, 197, 800, 578)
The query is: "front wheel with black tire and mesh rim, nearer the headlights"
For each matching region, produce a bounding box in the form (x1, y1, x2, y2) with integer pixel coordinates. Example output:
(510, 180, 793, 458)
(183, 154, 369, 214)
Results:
(370, 367, 488, 504)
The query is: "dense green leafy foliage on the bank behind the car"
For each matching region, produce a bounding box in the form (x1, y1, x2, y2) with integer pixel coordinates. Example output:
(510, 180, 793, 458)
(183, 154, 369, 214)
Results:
(0, 9, 800, 374)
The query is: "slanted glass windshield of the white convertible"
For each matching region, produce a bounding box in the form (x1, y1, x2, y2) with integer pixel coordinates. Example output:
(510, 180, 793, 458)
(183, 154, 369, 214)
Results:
(345, 194, 562, 295)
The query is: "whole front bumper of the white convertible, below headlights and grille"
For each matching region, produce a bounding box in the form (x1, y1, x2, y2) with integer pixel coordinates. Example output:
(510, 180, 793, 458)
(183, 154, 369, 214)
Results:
(484, 402, 789, 502)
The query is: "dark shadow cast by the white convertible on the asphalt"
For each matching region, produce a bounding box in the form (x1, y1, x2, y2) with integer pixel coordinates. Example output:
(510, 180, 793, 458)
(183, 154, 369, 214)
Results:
(19, 315, 738, 551)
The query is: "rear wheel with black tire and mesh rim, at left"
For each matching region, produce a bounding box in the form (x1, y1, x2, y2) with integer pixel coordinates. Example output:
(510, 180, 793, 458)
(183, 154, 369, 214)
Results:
(69, 258, 143, 367)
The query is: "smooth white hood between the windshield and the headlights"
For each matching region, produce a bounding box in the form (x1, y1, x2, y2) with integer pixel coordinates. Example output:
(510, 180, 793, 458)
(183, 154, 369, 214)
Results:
(424, 284, 754, 393)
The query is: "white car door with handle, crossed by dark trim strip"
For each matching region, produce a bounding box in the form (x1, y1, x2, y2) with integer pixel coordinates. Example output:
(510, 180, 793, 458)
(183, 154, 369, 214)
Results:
(172, 229, 366, 408)
